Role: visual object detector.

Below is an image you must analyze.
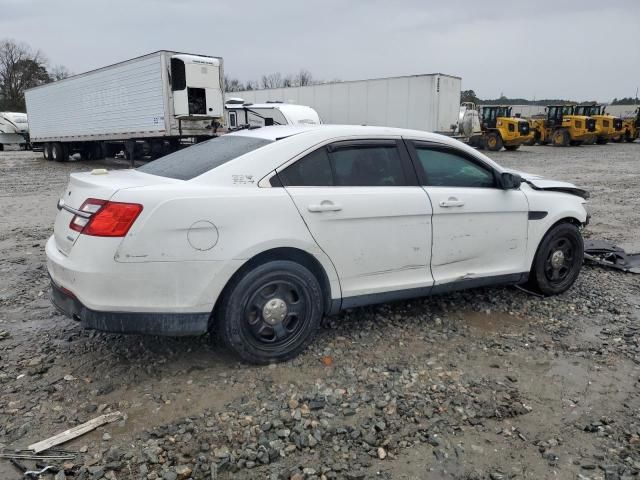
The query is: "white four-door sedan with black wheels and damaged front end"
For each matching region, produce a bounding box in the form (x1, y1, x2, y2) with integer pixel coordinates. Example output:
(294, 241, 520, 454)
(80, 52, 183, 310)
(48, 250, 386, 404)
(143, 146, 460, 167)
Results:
(46, 125, 588, 363)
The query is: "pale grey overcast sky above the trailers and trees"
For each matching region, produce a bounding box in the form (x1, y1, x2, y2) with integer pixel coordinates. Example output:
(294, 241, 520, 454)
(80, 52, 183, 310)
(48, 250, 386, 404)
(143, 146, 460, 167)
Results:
(0, 0, 640, 101)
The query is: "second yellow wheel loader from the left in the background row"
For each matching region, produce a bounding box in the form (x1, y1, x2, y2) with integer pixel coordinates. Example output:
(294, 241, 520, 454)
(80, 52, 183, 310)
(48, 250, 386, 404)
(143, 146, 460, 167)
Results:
(531, 105, 596, 147)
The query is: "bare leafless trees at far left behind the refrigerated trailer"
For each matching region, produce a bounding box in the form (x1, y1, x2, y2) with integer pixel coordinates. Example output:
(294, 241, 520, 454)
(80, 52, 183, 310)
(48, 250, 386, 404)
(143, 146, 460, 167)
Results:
(0, 39, 70, 112)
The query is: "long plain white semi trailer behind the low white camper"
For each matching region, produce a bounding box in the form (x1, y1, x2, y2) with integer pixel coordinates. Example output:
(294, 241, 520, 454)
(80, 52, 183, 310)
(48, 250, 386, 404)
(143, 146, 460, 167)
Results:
(228, 73, 461, 134)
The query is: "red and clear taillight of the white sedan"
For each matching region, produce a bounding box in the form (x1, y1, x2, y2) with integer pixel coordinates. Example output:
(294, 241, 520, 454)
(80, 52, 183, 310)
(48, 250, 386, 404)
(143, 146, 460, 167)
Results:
(69, 198, 142, 237)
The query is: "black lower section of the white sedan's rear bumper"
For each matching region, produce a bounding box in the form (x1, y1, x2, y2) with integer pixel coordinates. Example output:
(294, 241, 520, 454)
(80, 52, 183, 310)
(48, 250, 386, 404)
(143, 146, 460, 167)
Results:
(51, 281, 210, 336)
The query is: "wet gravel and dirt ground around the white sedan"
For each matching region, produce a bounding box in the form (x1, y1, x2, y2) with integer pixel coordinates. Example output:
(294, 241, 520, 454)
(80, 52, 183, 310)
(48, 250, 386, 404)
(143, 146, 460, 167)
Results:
(0, 144, 640, 480)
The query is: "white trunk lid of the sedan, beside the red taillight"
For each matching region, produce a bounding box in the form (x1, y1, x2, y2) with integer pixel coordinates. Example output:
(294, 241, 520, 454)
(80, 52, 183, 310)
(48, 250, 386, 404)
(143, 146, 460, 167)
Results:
(53, 169, 176, 255)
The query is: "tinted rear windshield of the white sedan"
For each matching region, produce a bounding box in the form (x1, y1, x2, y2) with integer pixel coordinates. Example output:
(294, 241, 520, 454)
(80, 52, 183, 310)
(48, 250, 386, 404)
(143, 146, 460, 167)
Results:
(138, 135, 272, 180)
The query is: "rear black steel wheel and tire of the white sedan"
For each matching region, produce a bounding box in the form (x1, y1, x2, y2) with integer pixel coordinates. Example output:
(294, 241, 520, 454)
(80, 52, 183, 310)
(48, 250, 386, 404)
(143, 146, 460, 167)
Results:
(215, 260, 324, 364)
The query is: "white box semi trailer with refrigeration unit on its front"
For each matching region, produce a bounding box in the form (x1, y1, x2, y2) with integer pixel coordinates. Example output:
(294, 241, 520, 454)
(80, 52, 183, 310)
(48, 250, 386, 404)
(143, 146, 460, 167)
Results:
(25, 50, 224, 161)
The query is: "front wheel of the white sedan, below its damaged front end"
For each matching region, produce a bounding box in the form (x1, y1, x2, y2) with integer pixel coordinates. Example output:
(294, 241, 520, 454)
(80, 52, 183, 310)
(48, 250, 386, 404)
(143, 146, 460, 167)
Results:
(528, 223, 584, 295)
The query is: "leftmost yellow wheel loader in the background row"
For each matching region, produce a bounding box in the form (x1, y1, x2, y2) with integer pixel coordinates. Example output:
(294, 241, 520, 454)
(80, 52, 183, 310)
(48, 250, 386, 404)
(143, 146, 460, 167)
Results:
(469, 105, 533, 151)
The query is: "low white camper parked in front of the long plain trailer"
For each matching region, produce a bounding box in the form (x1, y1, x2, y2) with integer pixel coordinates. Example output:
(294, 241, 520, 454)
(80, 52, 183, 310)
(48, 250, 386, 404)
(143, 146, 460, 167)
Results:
(225, 98, 322, 131)
